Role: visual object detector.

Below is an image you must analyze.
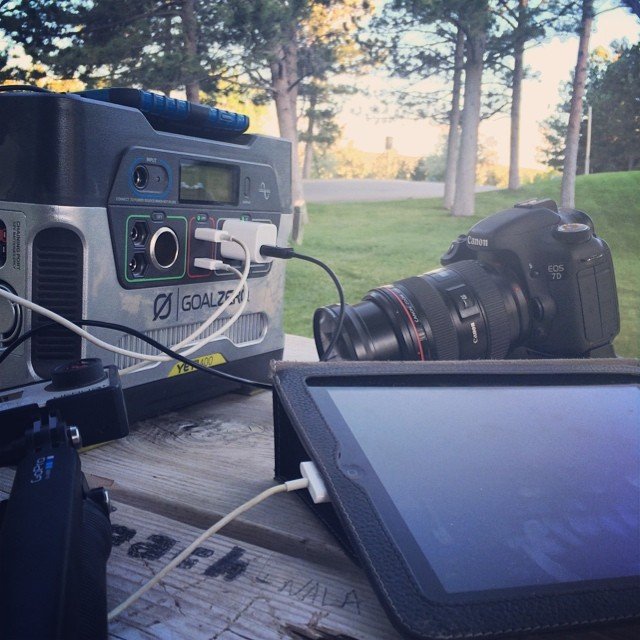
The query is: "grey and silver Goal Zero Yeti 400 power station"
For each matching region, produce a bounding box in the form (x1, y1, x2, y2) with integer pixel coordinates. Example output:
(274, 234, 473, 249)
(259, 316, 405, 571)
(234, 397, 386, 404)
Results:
(0, 93, 292, 420)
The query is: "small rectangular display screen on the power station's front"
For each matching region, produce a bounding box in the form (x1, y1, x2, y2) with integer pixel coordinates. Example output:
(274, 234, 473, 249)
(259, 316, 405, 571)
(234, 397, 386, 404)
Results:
(180, 162, 239, 204)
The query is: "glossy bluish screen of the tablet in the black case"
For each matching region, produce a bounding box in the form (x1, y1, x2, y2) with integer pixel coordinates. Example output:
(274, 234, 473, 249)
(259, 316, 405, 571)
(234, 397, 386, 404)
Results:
(309, 385, 640, 594)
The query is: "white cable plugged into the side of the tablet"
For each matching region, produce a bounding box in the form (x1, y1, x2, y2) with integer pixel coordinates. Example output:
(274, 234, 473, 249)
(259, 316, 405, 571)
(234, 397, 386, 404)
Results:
(107, 461, 329, 622)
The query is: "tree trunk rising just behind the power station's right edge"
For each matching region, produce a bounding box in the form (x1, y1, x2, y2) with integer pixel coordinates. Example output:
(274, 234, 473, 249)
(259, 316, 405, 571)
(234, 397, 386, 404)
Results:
(270, 38, 307, 243)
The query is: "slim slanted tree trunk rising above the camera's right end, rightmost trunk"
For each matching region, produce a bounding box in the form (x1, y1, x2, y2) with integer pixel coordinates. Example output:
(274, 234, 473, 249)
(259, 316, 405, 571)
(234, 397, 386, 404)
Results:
(560, 0, 593, 207)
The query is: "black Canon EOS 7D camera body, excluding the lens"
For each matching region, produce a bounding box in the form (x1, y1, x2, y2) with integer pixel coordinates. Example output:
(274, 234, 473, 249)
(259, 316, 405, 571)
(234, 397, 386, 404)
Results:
(441, 200, 620, 356)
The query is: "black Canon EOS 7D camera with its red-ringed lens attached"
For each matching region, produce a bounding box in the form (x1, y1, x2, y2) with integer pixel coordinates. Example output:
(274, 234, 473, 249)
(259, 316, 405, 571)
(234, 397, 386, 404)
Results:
(314, 200, 620, 360)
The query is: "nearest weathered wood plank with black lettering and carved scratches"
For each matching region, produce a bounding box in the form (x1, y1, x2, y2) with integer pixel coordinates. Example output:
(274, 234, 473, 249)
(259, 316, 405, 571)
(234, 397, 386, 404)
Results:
(108, 496, 399, 640)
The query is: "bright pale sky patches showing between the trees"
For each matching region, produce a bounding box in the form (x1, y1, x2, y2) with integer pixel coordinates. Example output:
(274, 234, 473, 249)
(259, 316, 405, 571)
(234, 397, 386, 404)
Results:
(330, 1, 640, 168)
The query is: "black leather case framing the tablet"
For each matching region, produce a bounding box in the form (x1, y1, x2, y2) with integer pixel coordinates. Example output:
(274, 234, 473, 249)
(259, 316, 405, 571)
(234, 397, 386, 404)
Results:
(273, 359, 640, 639)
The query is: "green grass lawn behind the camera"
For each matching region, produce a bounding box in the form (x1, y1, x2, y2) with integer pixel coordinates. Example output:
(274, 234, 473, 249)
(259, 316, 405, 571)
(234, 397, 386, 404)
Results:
(284, 171, 640, 358)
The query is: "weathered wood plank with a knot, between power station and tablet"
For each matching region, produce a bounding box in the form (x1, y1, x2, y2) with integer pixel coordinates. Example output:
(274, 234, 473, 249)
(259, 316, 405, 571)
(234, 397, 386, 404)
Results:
(82, 336, 341, 563)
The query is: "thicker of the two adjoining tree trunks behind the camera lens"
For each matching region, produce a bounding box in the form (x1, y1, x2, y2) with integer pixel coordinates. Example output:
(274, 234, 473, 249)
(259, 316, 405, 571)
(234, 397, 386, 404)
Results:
(451, 28, 487, 216)
